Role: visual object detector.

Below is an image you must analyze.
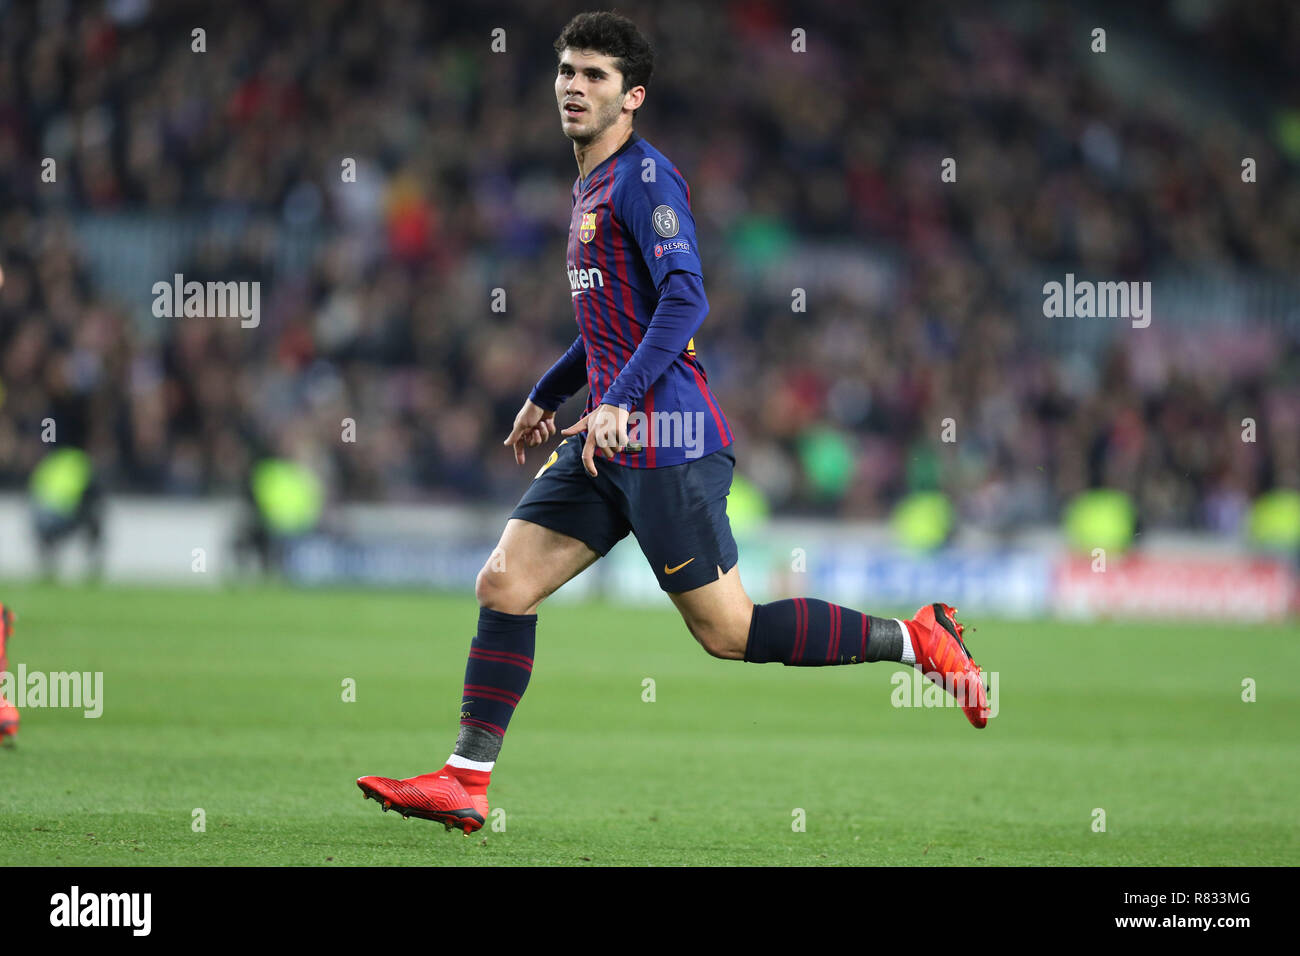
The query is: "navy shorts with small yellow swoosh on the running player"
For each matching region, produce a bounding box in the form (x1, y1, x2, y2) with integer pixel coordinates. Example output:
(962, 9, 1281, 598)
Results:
(510, 436, 737, 593)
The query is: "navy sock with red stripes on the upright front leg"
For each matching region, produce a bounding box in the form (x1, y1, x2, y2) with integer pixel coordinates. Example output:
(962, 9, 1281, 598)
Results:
(452, 607, 537, 773)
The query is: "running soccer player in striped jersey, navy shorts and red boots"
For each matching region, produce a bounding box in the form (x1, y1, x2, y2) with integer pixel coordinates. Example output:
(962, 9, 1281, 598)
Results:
(358, 13, 988, 834)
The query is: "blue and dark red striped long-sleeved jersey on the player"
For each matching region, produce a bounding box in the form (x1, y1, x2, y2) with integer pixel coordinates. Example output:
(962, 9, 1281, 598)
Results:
(553, 133, 732, 468)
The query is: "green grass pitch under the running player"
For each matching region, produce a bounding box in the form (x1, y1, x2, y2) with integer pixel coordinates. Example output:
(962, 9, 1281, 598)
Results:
(0, 584, 1300, 866)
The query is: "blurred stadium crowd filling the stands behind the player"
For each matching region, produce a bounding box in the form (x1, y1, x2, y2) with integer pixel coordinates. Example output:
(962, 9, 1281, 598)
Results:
(0, 0, 1300, 532)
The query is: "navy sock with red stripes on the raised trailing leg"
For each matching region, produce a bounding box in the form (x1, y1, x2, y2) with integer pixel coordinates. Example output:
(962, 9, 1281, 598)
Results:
(745, 597, 911, 667)
